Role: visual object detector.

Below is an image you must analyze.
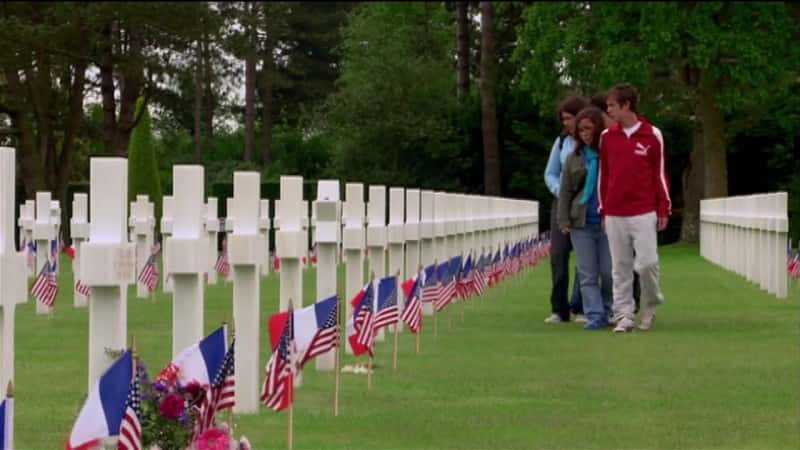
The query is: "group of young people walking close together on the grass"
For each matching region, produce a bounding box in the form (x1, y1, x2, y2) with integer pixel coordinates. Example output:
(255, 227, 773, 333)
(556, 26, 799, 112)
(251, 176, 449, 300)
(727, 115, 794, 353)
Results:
(544, 84, 671, 333)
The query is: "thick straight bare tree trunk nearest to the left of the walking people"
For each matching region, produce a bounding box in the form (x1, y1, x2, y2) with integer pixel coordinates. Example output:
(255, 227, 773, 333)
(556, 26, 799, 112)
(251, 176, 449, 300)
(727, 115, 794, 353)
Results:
(481, 2, 500, 195)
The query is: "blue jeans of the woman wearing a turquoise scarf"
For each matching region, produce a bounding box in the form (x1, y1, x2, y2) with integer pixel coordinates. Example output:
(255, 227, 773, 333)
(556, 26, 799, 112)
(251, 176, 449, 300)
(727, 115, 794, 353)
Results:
(570, 224, 613, 325)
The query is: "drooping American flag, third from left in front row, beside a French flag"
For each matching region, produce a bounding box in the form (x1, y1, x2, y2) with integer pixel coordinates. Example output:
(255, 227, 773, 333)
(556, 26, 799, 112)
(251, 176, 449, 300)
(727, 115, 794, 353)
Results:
(261, 310, 294, 411)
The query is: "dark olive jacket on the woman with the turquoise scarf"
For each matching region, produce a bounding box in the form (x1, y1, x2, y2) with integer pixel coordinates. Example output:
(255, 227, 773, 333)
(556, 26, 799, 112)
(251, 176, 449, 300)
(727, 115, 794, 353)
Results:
(556, 149, 588, 228)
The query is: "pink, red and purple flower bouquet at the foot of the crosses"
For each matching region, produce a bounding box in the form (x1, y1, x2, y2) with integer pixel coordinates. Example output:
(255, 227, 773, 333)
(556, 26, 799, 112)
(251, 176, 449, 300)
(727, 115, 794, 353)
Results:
(137, 362, 252, 450)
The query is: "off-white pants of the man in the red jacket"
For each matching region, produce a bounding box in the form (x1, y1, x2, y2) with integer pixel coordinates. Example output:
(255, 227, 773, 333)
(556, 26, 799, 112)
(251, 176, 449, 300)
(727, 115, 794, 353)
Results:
(606, 212, 664, 325)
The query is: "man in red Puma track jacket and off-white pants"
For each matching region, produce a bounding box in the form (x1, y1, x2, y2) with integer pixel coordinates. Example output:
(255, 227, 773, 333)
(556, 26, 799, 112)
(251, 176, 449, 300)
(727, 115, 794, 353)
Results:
(598, 84, 672, 333)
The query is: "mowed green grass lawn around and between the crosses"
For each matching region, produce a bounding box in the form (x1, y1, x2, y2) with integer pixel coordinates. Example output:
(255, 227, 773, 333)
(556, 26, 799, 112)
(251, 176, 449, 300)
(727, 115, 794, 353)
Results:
(9, 245, 800, 449)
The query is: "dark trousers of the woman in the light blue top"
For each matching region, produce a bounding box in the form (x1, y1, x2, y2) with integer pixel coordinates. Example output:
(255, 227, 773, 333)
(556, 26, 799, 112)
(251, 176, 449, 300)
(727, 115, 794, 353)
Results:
(550, 198, 583, 321)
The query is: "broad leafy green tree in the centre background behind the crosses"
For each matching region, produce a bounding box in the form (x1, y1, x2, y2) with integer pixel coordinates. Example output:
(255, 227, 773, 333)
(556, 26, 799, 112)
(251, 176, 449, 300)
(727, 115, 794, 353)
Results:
(323, 3, 464, 187)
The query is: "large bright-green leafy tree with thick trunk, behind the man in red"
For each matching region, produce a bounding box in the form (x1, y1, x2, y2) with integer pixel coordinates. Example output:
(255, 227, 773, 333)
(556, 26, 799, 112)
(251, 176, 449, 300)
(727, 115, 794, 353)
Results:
(515, 2, 800, 241)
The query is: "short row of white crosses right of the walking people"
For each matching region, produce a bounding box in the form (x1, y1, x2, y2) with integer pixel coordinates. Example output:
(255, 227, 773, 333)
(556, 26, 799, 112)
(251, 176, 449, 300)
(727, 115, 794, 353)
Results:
(700, 192, 789, 298)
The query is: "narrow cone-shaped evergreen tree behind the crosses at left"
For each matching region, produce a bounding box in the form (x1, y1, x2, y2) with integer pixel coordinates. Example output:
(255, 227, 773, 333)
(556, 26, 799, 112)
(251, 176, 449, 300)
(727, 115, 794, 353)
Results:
(128, 98, 163, 224)
